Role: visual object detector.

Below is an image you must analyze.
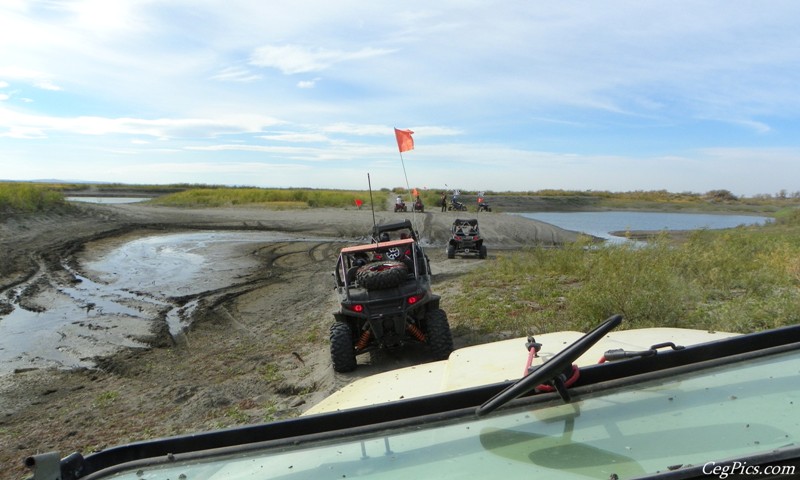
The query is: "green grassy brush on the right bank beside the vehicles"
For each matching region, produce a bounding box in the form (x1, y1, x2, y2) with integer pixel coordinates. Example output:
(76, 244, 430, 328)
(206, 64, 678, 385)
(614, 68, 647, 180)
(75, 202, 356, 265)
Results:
(446, 209, 800, 335)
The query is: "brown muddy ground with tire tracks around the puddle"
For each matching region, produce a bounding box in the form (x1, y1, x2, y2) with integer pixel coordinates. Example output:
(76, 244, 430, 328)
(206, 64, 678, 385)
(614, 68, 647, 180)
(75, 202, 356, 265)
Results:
(0, 204, 575, 478)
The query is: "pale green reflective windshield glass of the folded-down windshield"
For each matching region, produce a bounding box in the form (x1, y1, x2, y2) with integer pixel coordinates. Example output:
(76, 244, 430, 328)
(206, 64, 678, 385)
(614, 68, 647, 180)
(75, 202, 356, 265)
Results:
(100, 351, 800, 480)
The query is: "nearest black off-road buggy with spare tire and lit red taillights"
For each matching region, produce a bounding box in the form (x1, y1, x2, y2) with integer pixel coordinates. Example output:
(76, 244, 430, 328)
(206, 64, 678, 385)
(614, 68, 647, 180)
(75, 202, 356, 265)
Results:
(330, 220, 453, 372)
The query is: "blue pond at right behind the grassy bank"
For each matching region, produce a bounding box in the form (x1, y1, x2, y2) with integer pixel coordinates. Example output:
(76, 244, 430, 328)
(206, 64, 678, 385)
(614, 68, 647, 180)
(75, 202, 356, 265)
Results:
(518, 212, 772, 241)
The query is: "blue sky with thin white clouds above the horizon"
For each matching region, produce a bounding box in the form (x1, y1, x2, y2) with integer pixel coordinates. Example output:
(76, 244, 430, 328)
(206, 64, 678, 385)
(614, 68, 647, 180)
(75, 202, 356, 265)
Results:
(0, 0, 800, 196)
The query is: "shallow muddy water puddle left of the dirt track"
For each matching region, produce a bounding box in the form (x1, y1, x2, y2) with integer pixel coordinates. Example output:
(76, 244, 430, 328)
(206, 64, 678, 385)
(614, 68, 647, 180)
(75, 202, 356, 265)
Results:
(0, 231, 299, 374)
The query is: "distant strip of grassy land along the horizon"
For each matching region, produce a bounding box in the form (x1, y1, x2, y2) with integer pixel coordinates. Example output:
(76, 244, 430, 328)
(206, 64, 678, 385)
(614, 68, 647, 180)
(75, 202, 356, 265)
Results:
(7, 182, 800, 216)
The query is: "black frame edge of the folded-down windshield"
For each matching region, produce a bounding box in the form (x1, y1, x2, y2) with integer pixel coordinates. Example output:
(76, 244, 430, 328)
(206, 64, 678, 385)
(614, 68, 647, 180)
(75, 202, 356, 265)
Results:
(34, 325, 800, 480)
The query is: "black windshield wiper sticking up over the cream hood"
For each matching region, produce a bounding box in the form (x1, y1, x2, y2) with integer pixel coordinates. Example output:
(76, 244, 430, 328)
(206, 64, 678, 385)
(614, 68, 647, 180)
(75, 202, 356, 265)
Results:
(475, 315, 622, 417)
